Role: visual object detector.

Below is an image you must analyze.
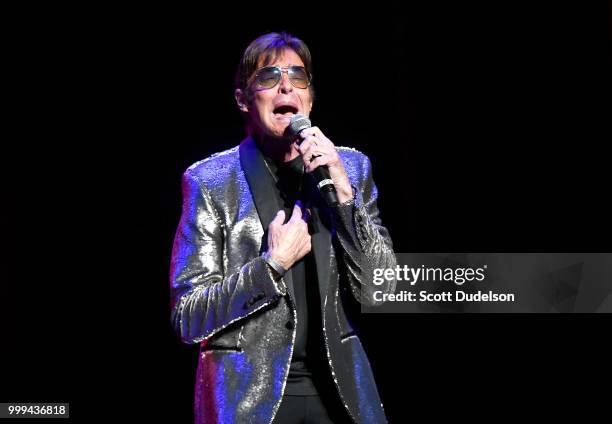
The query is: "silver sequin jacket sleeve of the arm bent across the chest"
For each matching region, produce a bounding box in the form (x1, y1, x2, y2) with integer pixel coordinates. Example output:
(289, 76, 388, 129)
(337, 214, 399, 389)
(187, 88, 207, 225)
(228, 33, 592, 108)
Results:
(170, 170, 286, 344)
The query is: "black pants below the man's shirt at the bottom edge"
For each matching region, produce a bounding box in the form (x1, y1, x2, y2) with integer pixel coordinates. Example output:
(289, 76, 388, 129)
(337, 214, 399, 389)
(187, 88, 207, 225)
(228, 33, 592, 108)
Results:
(273, 395, 353, 424)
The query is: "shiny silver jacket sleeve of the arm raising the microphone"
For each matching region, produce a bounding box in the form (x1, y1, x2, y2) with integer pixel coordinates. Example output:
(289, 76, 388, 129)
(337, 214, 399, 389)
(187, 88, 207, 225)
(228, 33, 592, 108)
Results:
(334, 155, 397, 306)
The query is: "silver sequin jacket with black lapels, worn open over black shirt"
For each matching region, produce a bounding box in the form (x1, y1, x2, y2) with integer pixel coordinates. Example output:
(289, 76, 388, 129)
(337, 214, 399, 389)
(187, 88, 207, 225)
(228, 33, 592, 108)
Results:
(170, 138, 396, 424)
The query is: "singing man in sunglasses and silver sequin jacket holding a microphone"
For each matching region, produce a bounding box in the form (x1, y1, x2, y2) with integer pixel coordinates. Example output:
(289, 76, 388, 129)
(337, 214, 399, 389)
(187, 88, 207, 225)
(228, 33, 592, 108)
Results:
(170, 33, 396, 424)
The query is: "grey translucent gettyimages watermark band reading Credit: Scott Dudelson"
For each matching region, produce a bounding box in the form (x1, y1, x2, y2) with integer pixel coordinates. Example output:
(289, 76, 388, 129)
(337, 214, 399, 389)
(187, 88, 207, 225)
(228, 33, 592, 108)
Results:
(361, 252, 612, 313)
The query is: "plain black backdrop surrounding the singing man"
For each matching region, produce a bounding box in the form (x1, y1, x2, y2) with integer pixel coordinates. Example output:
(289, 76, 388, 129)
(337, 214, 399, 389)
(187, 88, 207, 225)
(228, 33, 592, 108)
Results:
(0, 2, 612, 423)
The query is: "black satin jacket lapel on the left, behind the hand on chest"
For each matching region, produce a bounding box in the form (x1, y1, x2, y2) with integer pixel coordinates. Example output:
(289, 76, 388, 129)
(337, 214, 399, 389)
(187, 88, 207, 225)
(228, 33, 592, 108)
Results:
(238, 137, 295, 299)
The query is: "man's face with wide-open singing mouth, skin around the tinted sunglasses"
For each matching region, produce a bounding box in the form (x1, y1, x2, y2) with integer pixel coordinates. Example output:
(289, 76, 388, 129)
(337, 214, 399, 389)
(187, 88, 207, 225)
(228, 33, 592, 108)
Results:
(241, 49, 312, 138)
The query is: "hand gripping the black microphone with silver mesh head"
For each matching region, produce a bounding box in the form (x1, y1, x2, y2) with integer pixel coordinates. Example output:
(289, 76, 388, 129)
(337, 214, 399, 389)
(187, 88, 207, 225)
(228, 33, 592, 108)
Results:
(287, 114, 353, 207)
